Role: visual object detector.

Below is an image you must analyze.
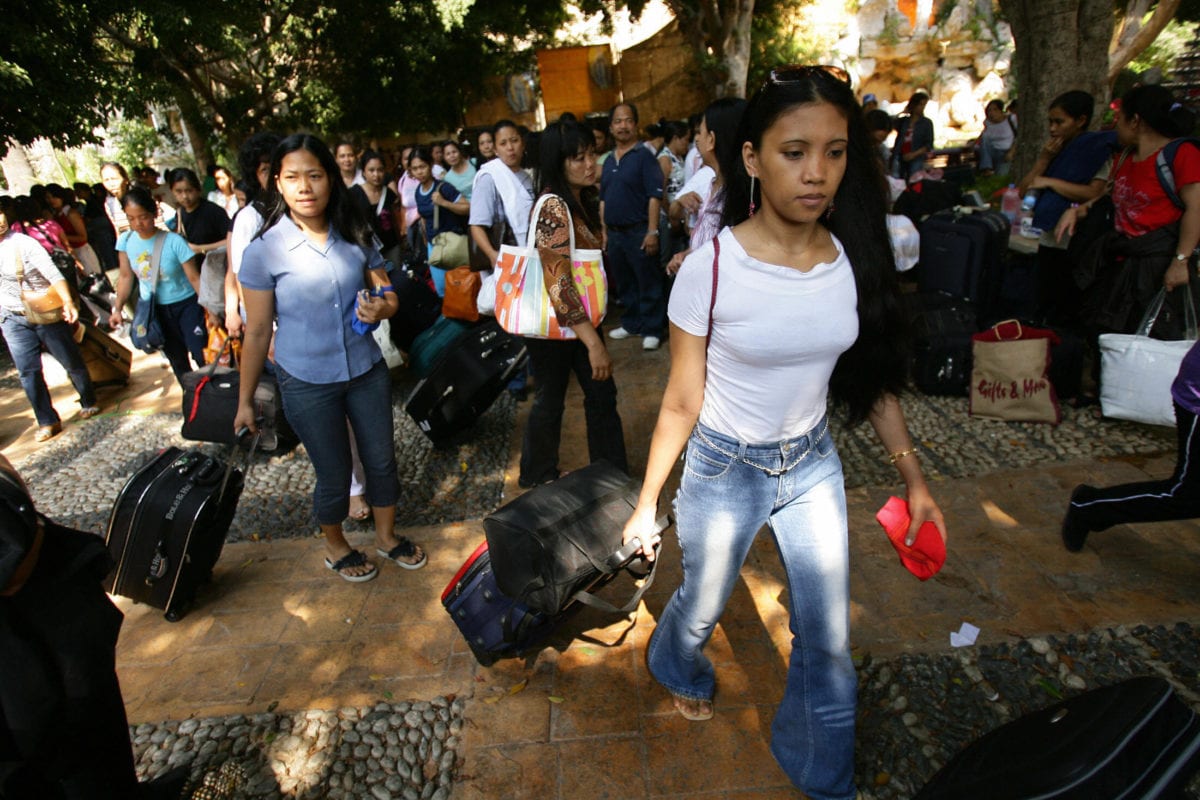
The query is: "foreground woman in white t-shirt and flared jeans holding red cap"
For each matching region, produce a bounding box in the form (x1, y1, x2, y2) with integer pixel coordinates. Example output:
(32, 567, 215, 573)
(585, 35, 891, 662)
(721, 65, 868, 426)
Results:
(624, 67, 946, 800)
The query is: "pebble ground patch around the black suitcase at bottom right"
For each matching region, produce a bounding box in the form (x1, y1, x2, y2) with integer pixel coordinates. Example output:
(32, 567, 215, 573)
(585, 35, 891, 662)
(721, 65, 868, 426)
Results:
(856, 622, 1200, 800)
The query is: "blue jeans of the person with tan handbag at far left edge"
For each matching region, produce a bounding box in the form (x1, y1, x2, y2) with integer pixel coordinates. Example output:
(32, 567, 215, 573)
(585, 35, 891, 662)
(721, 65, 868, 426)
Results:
(0, 311, 96, 426)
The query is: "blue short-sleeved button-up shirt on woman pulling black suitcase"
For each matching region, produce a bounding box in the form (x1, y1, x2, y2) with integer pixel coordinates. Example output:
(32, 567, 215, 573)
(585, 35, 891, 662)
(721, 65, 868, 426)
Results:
(238, 216, 384, 384)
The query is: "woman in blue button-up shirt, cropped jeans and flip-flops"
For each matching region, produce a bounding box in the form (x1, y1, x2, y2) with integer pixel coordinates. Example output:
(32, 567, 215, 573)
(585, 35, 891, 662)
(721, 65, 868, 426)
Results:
(234, 133, 426, 583)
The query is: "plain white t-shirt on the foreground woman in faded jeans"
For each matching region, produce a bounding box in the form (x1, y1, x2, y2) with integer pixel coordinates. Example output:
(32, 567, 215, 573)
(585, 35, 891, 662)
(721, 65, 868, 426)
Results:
(667, 228, 858, 444)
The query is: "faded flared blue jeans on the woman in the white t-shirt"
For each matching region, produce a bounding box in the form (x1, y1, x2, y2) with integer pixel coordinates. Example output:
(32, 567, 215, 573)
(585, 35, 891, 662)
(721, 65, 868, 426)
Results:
(647, 420, 857, 800)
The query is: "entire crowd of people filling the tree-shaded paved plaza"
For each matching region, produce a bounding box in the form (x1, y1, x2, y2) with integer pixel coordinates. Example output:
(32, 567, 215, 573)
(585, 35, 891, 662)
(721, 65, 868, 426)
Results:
(0, 66, 1200, 800)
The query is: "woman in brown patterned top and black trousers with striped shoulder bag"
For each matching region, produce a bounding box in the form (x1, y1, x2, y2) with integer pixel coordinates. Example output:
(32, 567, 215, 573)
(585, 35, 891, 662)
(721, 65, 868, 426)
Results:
(517, 121, 629, 488)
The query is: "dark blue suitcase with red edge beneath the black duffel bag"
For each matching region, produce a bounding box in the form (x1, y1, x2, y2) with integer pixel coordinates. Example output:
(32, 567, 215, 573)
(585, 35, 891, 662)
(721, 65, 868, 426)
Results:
(442, 542, 558, 667)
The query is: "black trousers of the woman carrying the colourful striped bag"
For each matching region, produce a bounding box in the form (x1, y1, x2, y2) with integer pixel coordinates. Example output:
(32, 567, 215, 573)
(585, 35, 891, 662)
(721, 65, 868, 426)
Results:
(521, 331, 629, 485)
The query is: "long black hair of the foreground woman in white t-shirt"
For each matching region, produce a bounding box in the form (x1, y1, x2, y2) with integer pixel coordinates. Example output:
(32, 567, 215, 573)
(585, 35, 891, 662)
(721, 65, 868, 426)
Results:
(720, 70, 908, 425)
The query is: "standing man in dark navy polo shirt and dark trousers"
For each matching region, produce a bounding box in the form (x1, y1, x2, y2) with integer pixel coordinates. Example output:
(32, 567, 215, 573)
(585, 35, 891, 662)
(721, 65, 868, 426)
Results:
(600, 103, 666, 350)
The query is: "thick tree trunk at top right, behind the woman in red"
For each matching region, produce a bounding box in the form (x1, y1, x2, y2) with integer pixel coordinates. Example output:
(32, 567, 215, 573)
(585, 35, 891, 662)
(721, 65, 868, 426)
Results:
(1004, 0, 1112, 179)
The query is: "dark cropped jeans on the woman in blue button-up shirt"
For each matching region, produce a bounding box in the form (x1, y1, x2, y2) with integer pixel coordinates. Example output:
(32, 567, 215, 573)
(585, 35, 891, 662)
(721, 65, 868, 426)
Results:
(275, 359, 400, 525)
